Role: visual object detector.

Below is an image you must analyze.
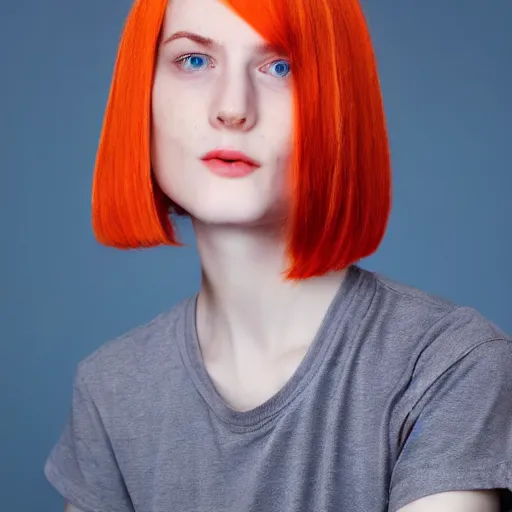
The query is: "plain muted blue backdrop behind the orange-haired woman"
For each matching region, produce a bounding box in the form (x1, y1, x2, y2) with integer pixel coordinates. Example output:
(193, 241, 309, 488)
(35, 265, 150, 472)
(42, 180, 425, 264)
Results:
(0, 0, 512, 512)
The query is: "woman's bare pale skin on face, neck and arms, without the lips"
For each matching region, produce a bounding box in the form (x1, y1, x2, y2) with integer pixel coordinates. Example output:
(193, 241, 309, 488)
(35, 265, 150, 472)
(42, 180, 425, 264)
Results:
(65, 0, 499, 512)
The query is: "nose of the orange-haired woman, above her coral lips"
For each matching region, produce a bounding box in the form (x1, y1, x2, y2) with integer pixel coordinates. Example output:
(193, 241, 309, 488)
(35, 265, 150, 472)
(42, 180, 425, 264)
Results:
(210, 70, 257, 132)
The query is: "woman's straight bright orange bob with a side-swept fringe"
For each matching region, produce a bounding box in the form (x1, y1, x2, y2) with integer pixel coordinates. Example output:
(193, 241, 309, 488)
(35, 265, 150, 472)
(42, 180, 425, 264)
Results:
(92, 0, 391, 280)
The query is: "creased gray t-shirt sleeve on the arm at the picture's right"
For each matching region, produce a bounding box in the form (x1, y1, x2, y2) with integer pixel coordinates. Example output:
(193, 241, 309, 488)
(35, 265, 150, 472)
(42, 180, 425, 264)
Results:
(388, 339, 512, 512)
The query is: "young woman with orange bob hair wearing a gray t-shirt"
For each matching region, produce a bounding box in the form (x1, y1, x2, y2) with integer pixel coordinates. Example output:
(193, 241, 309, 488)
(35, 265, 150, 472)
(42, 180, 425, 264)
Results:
(45, 0, 512, 512)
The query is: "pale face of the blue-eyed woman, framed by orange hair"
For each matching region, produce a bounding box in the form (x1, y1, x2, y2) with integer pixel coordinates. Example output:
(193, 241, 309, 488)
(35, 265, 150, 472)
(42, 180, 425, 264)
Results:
(151, 0, 293, 225)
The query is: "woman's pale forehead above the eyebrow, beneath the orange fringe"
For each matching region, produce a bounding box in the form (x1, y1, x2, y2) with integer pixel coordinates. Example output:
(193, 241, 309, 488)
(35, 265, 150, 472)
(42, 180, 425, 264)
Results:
(163, 0, 263, 46)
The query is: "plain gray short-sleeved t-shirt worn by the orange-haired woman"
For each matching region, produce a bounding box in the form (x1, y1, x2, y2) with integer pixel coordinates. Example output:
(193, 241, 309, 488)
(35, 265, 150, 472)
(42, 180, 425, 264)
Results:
(45, 266, 512, 512)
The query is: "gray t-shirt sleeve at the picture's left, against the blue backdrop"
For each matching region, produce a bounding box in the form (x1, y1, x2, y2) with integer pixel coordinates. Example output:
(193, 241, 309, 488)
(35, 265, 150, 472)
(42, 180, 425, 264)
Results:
(44, 371, 133, 512)
